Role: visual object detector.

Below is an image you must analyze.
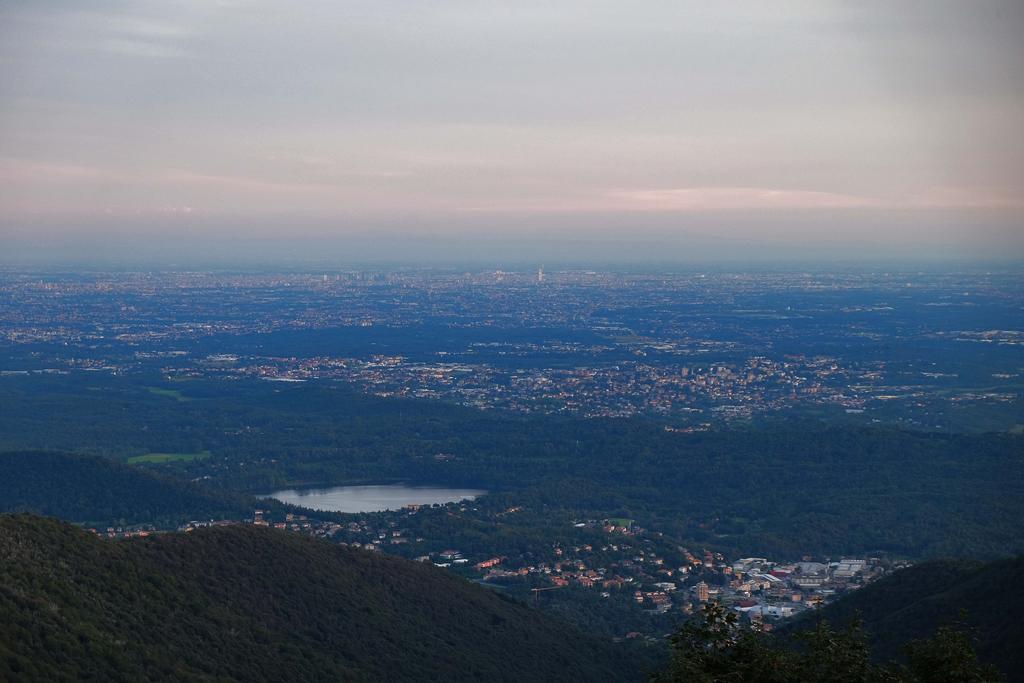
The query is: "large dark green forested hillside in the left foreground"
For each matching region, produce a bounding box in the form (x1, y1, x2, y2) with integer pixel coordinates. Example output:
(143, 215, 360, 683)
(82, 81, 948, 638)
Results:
(0, 515, 642, 681)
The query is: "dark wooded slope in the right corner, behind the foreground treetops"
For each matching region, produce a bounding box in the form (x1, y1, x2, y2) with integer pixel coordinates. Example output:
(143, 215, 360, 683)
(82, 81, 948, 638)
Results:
(785, 557, 1024, 681)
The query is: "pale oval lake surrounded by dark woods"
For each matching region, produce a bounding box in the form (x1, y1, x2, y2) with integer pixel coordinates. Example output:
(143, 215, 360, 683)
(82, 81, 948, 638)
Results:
(260, 484, 487, 512)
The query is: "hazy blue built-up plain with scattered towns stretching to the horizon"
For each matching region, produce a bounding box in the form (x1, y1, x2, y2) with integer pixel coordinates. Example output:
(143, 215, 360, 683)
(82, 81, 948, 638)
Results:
(0, 270, 1024, 430)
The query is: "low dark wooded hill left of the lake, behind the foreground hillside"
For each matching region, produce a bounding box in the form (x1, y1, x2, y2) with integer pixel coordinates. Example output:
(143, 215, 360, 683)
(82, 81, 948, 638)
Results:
(0, 452, 253, 526)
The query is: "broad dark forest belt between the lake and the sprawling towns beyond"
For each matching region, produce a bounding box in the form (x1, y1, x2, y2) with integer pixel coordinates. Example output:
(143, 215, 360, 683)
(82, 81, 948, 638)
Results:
(0, 378, 1024, 558)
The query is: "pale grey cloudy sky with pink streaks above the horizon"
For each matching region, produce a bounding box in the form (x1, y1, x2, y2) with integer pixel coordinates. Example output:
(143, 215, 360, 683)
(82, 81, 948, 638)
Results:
(0, 0, 1024, 262)
